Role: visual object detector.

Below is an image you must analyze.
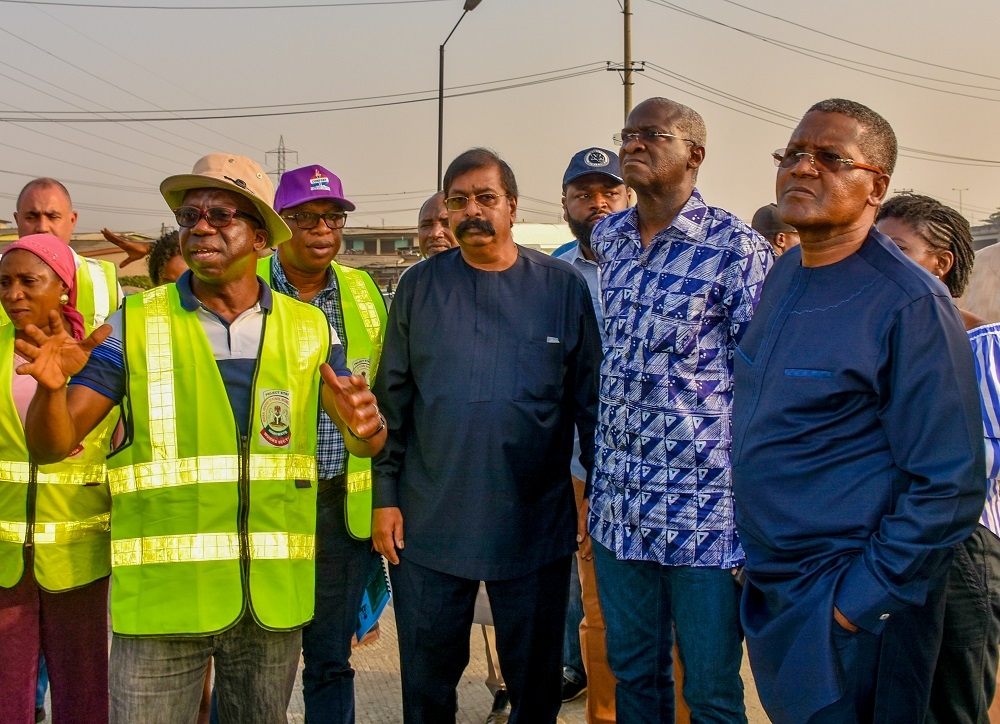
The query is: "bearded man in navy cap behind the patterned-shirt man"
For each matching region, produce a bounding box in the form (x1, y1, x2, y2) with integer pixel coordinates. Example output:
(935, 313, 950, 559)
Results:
(552, 148, 628, 724)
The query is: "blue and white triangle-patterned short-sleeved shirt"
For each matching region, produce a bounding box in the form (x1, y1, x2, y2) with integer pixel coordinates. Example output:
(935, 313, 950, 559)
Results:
(589, 190, 774, 568)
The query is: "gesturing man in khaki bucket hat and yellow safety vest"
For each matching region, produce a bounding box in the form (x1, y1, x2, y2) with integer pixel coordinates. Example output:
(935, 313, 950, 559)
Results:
(19, 153, 386, 724)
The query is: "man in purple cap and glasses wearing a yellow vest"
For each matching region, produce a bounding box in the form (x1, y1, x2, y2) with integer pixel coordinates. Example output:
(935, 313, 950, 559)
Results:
(257, 164, 386, 724)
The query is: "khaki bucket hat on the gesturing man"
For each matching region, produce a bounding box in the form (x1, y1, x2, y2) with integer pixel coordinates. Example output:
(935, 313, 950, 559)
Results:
(160, 153, 292, 246)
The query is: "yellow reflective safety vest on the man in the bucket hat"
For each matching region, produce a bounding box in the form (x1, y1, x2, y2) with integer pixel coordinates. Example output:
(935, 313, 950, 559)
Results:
(108, 284, 330, 636)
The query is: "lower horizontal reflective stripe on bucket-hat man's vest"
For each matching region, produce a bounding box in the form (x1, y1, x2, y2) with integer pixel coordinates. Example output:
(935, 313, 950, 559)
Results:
(111, 533, 316, 567)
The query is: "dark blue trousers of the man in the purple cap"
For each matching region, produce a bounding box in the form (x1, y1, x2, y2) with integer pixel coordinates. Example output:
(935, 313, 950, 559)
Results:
(302, 484, 381, 724)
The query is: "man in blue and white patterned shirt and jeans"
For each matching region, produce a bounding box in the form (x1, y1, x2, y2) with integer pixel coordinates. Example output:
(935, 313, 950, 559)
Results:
(588, 98, 773, 724)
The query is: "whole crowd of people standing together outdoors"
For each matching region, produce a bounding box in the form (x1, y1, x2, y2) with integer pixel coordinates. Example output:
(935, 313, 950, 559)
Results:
(0, 92, 1000, 724)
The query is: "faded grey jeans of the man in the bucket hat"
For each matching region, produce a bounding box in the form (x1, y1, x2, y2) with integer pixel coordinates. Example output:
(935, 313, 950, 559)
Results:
(108, 611, 302, 724)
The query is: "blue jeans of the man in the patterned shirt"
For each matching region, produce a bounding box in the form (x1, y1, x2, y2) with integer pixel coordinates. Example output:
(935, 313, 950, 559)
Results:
(594, 541, 747, 724)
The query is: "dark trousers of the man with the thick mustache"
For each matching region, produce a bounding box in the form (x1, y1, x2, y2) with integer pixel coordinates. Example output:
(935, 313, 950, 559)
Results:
(390, 556, 571, 724)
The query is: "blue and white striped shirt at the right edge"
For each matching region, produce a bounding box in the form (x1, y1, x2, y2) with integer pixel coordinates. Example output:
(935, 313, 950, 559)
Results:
(969, 324, 1000, 536)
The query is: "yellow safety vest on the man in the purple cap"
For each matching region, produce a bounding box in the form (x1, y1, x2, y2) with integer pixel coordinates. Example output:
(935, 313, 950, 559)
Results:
(257, 252, 388, 540)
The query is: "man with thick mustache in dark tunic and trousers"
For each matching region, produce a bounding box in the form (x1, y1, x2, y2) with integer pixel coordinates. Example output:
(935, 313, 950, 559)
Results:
(372, 148, 600, 724)
